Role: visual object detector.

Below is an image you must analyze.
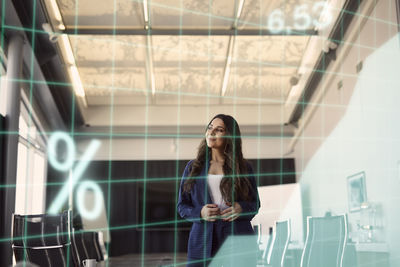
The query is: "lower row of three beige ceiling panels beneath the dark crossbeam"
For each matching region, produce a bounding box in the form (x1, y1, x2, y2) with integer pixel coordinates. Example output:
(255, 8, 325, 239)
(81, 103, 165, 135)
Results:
(69, 35, 309, 106)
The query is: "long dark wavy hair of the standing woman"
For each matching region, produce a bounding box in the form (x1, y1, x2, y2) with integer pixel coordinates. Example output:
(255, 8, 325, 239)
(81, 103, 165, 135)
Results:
(183, 114, 252, 203)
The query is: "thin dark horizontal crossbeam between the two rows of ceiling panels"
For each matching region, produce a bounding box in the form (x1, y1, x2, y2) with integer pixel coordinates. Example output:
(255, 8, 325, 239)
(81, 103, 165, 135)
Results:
(62, 26, 318, 36)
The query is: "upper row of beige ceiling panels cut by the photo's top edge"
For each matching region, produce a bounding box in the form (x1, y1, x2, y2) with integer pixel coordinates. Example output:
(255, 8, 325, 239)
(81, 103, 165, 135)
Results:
(57, 0, 323, 30)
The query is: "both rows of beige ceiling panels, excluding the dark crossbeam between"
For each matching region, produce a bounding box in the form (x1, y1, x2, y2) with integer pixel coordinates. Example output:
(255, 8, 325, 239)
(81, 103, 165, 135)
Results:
(57, 0, 316, 107)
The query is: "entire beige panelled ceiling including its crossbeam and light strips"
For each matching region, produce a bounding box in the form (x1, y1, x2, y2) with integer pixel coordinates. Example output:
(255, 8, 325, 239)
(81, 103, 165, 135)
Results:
(38, 0, 340, 134)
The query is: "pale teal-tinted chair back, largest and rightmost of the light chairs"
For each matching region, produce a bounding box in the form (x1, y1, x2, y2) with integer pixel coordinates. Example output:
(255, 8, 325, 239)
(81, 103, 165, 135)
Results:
(300, 215, 347, 267)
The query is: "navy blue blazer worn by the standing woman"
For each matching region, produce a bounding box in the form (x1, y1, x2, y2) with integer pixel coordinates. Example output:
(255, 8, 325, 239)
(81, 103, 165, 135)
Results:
(177, 160, 260, 259)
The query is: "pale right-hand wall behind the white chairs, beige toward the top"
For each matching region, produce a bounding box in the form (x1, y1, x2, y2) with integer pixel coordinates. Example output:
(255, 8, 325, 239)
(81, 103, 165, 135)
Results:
(295, 0, 400, 266)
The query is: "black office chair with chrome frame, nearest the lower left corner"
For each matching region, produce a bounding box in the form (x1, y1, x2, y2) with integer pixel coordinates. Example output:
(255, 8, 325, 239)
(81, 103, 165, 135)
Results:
(12, 211, 71, 267)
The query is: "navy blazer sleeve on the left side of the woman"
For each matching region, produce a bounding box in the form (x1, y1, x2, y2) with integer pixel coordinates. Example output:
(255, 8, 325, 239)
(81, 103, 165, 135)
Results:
(177, 161, 203, 222)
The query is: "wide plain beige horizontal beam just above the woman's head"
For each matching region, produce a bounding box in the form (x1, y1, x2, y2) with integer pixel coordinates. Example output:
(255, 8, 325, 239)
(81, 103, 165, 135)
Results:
(83, 103, 285, 127)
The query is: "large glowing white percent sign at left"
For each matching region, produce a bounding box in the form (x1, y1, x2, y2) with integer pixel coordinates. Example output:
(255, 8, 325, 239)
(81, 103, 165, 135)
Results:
(47, 132, 103, 220)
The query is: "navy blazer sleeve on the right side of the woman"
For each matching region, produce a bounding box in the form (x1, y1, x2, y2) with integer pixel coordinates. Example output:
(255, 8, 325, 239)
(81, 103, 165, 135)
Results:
(238, 163, 261, 221)
